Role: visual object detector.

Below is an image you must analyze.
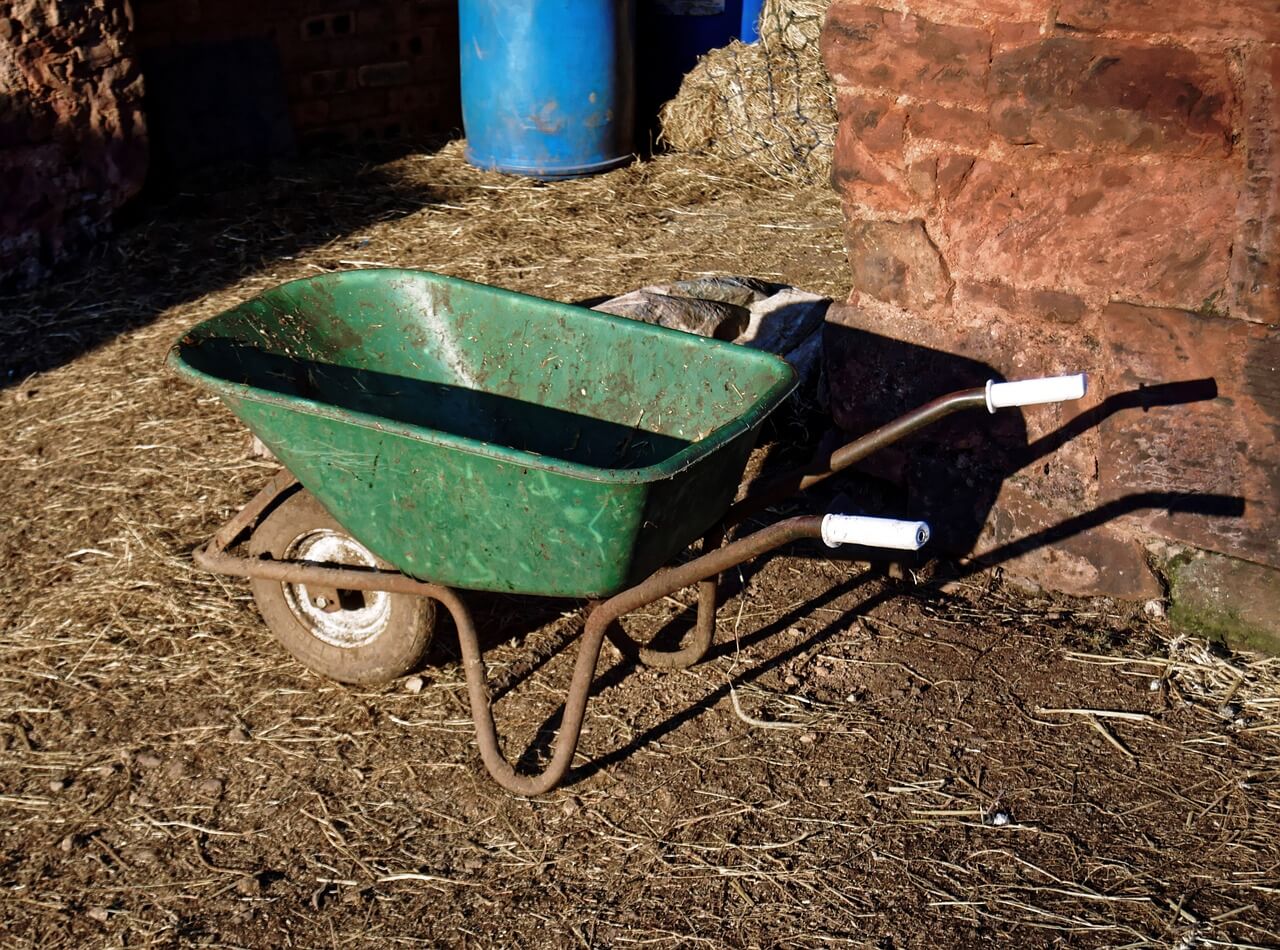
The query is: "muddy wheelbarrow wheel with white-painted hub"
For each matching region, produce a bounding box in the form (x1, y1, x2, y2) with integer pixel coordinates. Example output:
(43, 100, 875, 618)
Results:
(248, 489, 435, 685)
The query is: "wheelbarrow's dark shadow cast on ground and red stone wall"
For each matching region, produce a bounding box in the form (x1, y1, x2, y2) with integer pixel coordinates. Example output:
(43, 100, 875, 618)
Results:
(486, 325, 1244, 782)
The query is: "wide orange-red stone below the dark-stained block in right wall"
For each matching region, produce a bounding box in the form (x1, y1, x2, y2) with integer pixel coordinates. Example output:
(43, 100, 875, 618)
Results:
(938, 160, 1238, 307)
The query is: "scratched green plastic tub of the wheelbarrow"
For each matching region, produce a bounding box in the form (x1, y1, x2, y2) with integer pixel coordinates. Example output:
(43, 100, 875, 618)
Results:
(170, 270, 795, 597)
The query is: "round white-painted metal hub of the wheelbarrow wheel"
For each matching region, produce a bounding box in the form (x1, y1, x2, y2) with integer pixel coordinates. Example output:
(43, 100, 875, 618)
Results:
(280, 527, 392, 649)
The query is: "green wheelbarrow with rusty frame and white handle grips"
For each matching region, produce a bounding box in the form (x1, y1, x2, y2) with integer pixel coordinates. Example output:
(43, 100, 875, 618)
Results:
(169, 270, 1085, 795)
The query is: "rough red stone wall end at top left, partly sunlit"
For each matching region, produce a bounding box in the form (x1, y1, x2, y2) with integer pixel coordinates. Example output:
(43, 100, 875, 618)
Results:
(0, 0, 146, 284)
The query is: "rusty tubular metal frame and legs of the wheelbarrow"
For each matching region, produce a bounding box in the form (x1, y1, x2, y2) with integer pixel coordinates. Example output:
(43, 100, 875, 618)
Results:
(193, 389, 986, 795)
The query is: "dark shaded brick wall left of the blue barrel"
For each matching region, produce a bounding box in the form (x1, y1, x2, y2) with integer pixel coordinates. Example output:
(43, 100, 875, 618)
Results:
(132, 0, 461, 146)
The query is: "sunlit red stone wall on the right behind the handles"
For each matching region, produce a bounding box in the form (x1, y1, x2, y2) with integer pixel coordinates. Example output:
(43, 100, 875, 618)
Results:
(823, 0, 1280, 597)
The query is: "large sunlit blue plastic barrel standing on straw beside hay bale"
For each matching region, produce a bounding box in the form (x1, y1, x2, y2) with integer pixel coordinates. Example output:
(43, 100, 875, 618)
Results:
(458, 0, 635, 178)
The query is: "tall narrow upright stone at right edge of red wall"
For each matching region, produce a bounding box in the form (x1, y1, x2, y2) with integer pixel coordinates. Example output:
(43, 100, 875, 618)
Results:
(1229, 47, 1280, 324)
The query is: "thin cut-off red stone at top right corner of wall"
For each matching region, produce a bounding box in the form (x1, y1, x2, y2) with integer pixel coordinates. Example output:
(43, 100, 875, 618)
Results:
(1057, 0, 1280, 42)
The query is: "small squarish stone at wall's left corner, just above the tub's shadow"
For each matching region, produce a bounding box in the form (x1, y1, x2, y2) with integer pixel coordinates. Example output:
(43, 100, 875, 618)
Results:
(845, 220, 951, 310)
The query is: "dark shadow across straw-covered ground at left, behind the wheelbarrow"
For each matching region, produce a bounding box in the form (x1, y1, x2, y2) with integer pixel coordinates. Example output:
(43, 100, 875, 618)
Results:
(0, 140, 460, 388)
